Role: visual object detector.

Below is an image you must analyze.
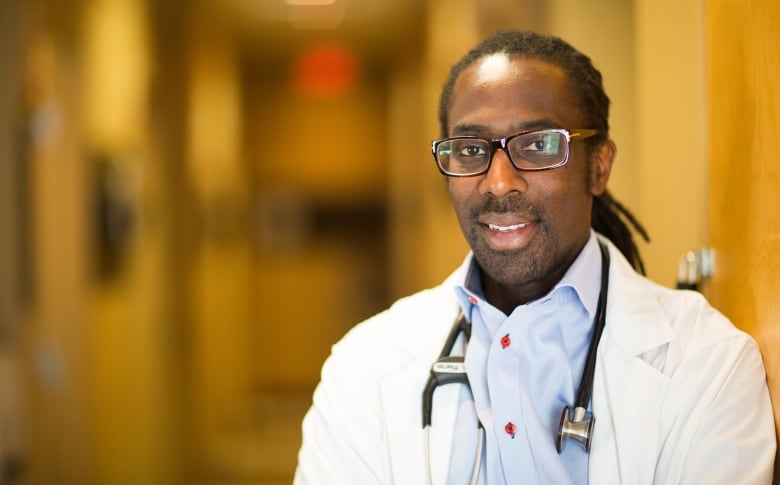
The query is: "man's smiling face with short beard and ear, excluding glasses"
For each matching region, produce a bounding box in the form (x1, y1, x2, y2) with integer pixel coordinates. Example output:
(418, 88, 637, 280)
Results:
(448, 55, 614, 299)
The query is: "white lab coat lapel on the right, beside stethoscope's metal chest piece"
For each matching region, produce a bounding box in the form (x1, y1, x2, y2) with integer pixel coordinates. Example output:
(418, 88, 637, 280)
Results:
(589, 241, 673, 484)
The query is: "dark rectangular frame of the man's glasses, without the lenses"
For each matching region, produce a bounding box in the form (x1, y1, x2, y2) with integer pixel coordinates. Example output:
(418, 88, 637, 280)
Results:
(431, 128, 599, 177)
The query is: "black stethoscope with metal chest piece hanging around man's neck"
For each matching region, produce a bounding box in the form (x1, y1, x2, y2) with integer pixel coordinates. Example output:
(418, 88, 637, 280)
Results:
(422, 241, 609, 485)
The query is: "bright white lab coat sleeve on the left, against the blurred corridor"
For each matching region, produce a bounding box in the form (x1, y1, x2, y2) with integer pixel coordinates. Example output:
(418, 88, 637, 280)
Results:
(293, 322, 389, 485)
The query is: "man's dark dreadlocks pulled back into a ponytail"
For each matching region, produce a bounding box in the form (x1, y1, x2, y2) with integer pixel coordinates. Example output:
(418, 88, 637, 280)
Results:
(439, 30, 650, 274)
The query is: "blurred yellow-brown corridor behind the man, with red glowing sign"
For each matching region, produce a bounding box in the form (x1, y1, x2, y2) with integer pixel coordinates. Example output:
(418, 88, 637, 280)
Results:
(0, 0, 776, 485)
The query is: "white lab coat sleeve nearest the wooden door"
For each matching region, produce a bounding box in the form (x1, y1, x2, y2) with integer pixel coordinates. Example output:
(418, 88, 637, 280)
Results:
(672, 335, 776, 485)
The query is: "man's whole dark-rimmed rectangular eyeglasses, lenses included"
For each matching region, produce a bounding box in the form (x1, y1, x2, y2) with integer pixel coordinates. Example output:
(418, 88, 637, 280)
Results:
(431, 128, 598, 177)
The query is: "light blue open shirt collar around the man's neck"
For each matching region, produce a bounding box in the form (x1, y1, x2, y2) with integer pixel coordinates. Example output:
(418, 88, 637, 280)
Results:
(457, 229, 602, 318)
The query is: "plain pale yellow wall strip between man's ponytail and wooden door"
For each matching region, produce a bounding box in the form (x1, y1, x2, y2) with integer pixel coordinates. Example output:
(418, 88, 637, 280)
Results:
(635, 0, 708, 285)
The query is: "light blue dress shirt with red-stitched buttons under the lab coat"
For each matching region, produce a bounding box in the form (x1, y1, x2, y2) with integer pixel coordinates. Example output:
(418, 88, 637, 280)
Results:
(447, 231, 601, 485)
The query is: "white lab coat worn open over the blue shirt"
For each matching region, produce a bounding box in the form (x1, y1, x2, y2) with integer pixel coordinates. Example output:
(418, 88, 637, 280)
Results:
(294, 238, 776, 485)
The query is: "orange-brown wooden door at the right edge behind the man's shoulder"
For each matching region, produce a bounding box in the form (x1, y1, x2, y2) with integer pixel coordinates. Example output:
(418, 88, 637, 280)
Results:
(705, 0, 780, 483)
